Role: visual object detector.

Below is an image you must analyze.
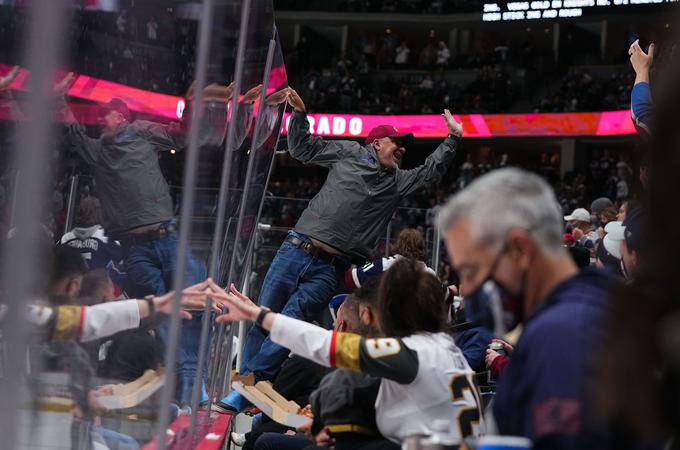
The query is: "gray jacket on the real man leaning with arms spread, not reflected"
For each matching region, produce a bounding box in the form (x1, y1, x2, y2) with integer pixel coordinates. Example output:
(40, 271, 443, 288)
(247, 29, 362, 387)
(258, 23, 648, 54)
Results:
(288, 112, 460, 260)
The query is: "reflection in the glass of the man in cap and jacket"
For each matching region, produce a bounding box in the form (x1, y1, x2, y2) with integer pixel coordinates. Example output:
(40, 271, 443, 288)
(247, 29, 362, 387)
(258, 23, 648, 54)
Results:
(56, 70, 240, 405)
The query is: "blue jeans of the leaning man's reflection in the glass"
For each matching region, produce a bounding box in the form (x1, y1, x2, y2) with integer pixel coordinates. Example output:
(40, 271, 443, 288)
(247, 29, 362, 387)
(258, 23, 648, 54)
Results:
(125, 220, 208, 405)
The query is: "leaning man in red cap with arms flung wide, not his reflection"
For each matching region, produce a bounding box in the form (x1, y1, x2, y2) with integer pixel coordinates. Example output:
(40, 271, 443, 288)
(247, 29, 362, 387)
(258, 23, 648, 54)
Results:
(215, 88, 463, 412)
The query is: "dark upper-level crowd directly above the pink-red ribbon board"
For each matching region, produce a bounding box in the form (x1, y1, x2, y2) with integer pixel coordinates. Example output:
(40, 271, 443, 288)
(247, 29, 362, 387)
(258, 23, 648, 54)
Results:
(288, 30, 644, 114)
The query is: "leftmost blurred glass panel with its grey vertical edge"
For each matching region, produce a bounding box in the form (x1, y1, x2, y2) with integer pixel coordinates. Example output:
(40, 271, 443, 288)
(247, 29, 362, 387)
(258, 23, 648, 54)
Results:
(0, 1, 74, 449)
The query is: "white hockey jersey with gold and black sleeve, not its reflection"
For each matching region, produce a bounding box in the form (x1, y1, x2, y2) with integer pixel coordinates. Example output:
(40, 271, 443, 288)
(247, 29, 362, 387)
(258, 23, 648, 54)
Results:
(270, 314, 481, 442)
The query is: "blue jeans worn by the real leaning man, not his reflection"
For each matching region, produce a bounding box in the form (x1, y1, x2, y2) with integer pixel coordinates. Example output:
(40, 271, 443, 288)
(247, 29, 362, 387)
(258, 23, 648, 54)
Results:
(223, 230, 342, 409)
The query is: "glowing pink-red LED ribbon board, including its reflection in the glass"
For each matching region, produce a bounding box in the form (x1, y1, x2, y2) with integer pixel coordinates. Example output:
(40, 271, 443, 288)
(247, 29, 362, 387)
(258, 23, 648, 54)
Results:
(0, 65, 636, 138)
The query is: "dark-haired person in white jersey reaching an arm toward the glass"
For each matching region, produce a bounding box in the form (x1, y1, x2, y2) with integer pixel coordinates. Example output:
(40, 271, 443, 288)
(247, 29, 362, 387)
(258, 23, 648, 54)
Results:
(197, 258, 481, 449)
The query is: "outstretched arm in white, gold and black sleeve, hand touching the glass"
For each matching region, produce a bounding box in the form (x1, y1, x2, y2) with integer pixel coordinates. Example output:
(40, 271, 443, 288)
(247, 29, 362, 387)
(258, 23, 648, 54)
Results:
(205, 285, 418, 384)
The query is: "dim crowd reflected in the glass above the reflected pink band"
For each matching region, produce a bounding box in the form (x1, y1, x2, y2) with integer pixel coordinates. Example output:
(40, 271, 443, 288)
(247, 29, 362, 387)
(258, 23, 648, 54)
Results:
(0, 2, 198, 95)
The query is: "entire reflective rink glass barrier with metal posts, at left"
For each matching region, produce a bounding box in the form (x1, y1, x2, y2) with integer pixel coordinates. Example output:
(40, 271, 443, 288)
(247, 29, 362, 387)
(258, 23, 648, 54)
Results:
(0, 0, 287, 449)
